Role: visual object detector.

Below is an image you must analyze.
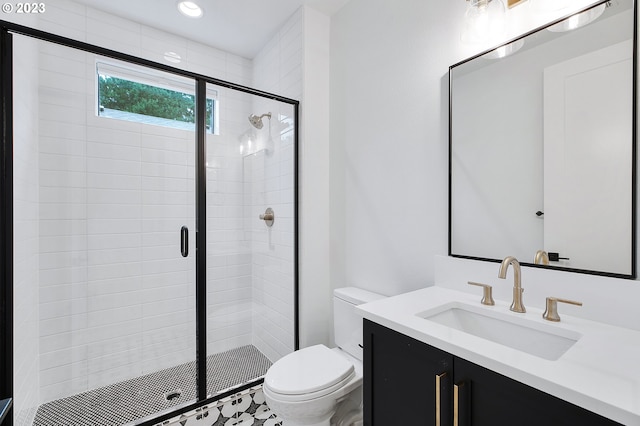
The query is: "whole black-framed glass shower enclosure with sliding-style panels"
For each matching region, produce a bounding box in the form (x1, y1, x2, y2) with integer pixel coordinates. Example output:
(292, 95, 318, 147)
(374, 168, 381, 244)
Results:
(0, 17, 298, 426)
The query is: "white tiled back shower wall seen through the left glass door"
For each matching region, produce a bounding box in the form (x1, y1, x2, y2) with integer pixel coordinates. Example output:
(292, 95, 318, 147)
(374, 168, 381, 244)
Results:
(39, 42, 200, 402)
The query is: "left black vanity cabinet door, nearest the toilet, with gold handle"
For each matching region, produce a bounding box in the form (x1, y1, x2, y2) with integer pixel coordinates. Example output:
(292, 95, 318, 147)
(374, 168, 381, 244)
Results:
(363, 320, 453, 426)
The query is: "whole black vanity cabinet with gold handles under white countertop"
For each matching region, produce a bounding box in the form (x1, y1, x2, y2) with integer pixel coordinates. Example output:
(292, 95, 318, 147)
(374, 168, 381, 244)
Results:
(364, 320, 619, 426)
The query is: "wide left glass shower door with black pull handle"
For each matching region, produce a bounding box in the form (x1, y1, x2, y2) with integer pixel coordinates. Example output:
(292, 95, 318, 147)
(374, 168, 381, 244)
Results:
(14, 36, 197, 426)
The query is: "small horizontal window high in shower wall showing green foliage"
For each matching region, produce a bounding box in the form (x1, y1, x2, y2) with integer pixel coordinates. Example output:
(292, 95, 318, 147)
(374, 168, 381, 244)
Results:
(96, 62, 220, 135)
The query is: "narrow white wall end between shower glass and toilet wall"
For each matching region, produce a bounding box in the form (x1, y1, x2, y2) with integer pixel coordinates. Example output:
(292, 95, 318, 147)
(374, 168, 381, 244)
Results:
(299, 7, 332, 347)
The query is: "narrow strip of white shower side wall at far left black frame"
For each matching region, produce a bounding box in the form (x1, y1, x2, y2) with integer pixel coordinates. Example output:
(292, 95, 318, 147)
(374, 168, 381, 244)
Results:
(13, 28, 40, 426)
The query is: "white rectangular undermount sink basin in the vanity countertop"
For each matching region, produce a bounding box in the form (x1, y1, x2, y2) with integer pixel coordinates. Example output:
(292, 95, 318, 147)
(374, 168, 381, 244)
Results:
(418, 303, 581, 361)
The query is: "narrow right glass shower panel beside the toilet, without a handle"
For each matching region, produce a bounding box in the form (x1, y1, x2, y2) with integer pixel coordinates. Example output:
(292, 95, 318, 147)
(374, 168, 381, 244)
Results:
(206, 80, 295, 406)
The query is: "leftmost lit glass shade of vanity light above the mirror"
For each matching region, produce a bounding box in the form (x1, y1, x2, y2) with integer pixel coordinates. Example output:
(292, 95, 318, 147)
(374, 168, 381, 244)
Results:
(461, 0, 506, 43)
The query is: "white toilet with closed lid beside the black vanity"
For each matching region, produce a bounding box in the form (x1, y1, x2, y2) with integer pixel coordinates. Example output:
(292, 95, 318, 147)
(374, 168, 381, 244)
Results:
(262, 287, 384, 426)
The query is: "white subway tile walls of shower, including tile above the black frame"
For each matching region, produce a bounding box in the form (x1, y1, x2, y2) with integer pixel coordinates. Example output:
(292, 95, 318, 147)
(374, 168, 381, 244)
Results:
(5, 0, 302, 416)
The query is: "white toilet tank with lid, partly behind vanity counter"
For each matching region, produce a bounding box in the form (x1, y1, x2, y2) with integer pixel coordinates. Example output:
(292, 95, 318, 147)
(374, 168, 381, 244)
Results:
(333, 287, 385, 360)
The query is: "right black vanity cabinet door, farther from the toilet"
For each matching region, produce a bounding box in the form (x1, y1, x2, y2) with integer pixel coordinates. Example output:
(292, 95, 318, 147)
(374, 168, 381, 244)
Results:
(454, 357, 618, 426)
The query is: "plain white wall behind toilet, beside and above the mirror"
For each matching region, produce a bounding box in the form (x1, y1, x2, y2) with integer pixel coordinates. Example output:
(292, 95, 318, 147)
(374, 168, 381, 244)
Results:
(330, 0, 628, 302)
